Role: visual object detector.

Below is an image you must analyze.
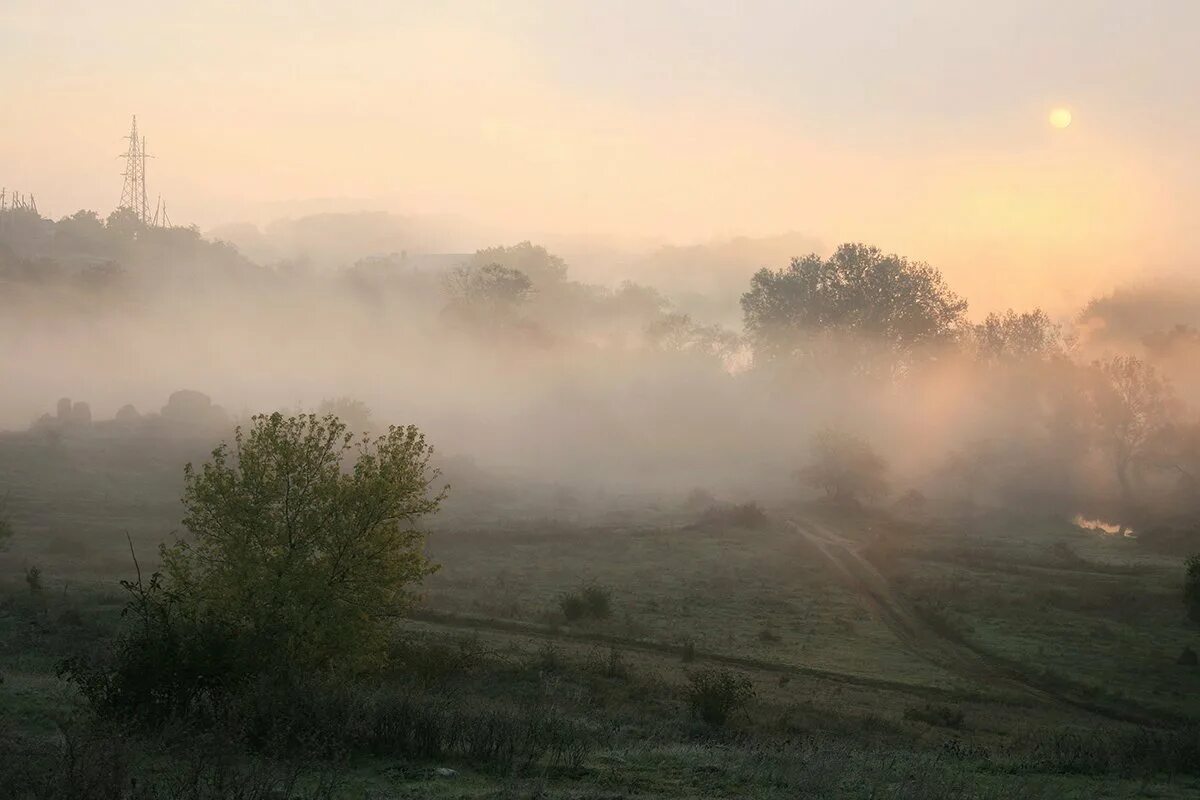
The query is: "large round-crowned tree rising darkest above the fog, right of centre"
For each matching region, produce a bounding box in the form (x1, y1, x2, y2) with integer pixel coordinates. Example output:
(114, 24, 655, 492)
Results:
(742, 245, 967, 372)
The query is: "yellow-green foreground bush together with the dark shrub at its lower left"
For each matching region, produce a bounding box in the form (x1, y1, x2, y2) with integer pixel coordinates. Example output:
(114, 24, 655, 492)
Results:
(62, 414, 444, 722)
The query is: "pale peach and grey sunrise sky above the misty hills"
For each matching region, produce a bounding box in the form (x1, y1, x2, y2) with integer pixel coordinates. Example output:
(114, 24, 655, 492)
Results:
(0, 0, 1200, 307)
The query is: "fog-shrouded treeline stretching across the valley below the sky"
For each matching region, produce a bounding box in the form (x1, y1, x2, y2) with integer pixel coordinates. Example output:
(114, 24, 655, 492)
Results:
(0, 206, 1200, 541)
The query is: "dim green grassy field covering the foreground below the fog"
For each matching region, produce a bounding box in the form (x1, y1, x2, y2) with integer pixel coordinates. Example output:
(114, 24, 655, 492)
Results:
(0, 437, 1200, 800)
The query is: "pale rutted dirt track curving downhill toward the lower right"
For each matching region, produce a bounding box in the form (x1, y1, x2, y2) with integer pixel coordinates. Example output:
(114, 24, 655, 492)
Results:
(788, 519, 1162, 724)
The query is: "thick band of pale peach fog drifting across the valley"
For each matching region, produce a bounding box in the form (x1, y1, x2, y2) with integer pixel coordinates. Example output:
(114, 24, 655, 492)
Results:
(0, 203, 1200, 534)
